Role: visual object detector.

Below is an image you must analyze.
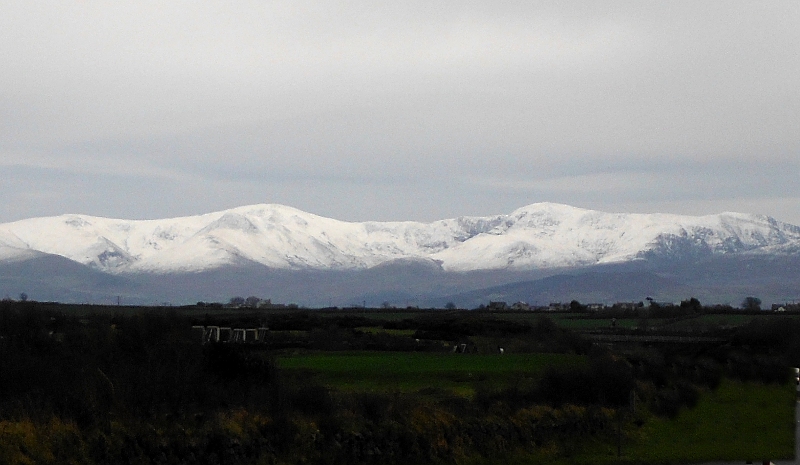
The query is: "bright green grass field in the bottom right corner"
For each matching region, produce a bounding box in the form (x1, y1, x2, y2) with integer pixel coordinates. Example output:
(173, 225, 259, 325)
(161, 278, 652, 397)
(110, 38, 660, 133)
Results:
(570, 380, 797, 464)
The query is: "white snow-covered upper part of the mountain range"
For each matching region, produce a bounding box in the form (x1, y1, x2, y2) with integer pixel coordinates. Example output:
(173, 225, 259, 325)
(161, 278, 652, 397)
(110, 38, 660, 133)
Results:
(0, 203, 800, 273)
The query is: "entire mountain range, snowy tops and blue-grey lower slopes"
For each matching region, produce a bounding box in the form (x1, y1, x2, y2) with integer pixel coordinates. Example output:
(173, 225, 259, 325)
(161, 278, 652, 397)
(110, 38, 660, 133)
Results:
(0, 203, 800, 306)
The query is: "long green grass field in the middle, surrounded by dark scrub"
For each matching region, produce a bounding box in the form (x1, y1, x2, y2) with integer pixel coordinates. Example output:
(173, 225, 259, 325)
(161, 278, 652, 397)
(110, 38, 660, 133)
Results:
(277, 352, 586, 396)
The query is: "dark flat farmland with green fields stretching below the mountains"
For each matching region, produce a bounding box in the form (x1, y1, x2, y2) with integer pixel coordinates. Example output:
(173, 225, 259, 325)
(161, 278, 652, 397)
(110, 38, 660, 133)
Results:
(0, 302, 800, 464)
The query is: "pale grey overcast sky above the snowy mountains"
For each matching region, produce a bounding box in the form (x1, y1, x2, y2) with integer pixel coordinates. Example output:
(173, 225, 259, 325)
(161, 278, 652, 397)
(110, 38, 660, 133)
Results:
(0, 0, 800, 225)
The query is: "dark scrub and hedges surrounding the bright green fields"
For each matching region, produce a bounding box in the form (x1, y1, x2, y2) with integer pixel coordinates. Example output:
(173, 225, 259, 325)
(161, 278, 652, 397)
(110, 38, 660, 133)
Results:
(0, 301, 800, 464)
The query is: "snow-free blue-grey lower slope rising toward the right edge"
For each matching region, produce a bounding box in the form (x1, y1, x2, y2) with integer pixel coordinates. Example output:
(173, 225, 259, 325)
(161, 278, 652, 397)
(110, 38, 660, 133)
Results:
(438, 254, 800, 308)
